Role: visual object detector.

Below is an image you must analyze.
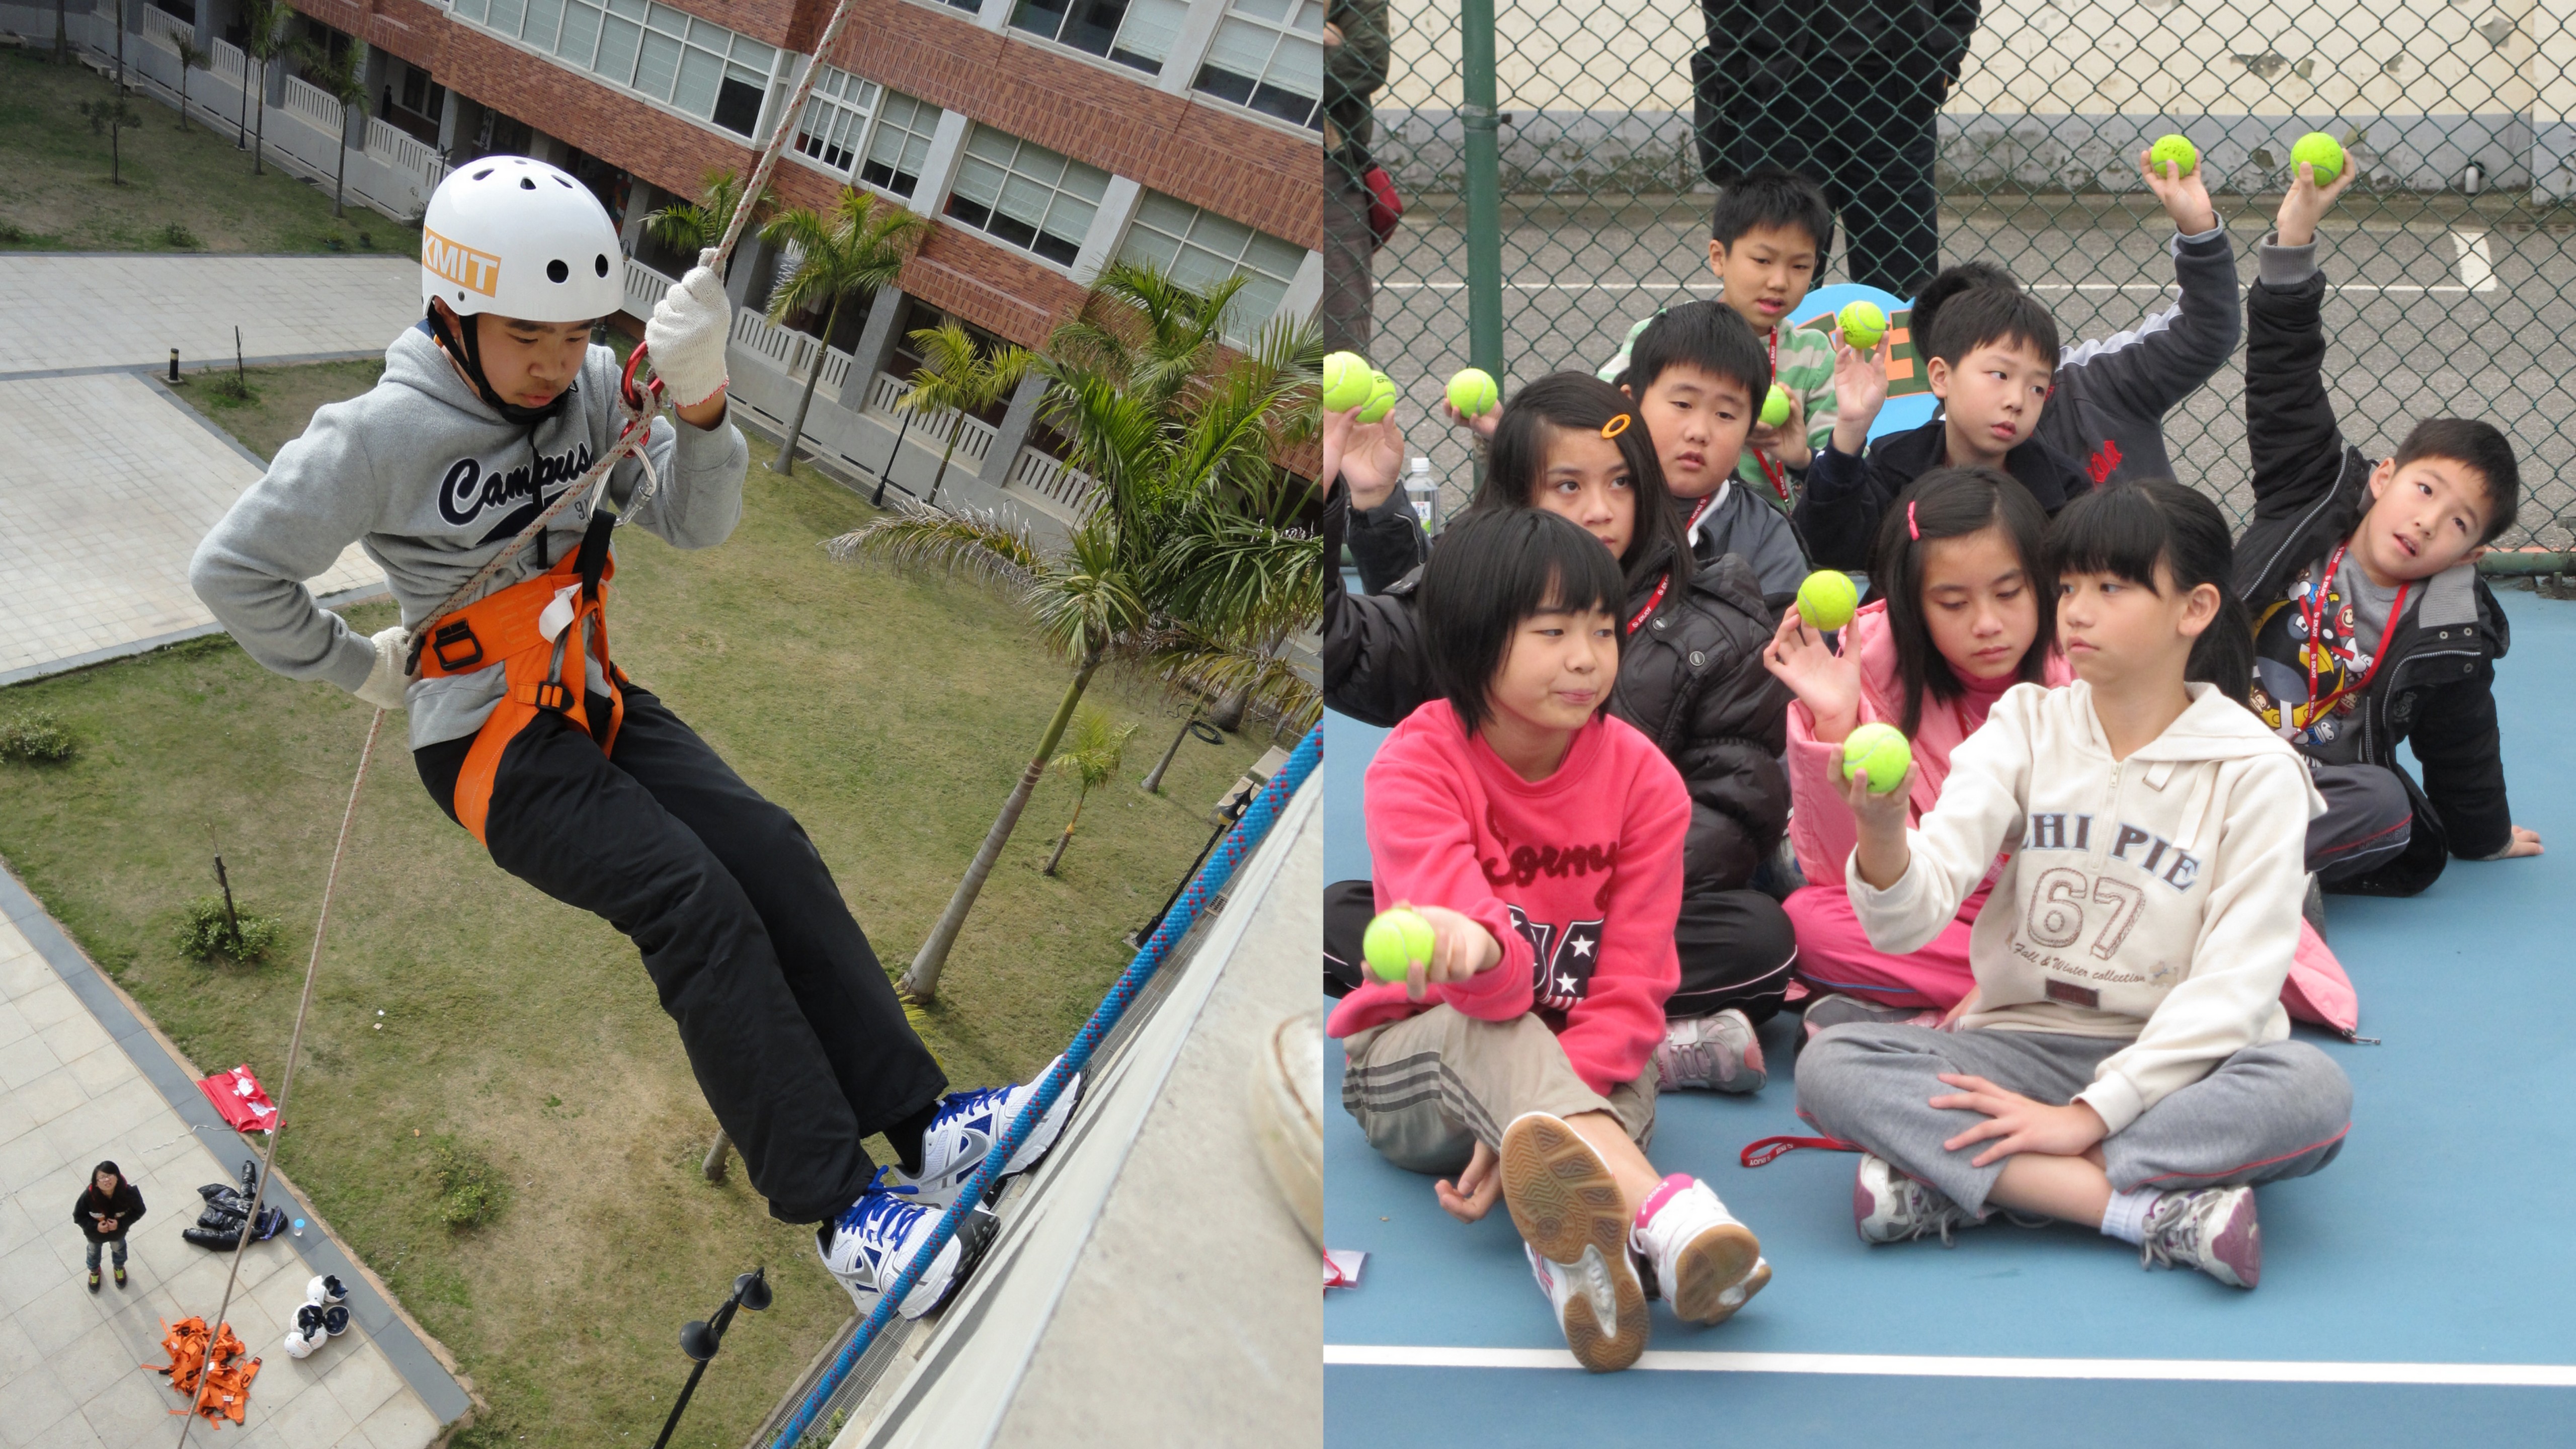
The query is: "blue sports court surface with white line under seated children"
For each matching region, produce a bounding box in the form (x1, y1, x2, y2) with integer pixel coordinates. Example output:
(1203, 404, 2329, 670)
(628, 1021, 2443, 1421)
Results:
(1324, 591, 2576, 1449)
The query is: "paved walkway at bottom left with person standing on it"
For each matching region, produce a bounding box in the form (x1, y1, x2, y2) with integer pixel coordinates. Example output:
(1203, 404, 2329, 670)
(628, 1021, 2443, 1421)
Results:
(0, 871, 466, 1449)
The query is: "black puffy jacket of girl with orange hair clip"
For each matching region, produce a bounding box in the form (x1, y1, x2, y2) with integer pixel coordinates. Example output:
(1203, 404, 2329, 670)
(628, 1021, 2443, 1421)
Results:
(1324, 485, 1790, 892)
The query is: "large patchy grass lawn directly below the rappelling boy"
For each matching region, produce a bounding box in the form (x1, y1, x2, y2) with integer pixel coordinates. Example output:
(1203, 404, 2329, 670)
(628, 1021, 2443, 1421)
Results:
(0, 368, 1267, 1449)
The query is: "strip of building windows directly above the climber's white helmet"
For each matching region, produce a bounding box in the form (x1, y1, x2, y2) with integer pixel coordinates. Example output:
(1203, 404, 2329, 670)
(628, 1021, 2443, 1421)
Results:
(451, 0, 778, 137)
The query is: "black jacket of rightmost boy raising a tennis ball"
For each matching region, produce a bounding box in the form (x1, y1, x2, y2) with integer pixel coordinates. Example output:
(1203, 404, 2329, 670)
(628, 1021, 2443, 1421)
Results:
(2236, 245, 2514, 895)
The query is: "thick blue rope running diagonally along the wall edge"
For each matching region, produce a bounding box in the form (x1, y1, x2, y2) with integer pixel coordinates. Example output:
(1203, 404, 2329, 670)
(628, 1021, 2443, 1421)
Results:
(770, 725, 1324, 1449)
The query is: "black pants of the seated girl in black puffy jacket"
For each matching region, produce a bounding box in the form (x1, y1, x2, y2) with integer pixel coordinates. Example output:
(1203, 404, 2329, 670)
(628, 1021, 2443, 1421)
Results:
(1324, 879, 1798, 1026)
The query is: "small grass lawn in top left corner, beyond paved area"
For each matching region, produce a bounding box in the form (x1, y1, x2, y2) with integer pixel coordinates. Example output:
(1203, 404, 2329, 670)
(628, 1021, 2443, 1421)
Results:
(0, 36, 420, 255)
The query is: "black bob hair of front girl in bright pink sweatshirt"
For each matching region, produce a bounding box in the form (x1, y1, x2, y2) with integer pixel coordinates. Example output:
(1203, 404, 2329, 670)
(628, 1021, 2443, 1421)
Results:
(1414, 508, 1626, 735)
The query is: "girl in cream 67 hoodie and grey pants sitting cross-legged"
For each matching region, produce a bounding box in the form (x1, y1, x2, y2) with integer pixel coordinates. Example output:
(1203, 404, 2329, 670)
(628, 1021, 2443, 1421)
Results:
(1798, 482, 2352, 1289)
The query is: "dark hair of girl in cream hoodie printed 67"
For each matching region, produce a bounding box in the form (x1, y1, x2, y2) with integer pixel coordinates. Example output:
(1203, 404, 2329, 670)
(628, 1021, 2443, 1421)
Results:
(2048, 477, 2254, 709)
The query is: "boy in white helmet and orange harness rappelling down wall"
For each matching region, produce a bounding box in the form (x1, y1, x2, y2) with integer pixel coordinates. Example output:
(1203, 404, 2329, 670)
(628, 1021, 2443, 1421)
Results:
(188, 157, 1079, 1318)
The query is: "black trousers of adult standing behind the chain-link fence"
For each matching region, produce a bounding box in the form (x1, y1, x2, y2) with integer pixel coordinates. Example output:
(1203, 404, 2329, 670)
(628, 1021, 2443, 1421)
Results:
(1703, 57, 1940, 296)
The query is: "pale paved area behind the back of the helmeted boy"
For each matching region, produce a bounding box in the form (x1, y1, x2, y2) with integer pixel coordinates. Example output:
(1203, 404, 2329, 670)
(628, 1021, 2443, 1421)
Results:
(0, 255, 420, 686)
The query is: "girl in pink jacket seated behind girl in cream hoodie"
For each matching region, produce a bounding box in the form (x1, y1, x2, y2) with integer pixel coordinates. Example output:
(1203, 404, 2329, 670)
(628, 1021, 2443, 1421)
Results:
(1764, 467, 2360, 1036)
